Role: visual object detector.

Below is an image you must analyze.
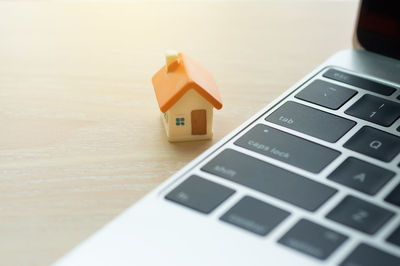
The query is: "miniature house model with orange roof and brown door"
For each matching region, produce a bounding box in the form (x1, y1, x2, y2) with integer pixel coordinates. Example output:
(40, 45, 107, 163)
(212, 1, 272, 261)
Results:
(152, 51, 222, 142)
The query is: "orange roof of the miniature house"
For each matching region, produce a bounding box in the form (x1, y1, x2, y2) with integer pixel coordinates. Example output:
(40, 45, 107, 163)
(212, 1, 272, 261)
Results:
(152, 53, 222, 113)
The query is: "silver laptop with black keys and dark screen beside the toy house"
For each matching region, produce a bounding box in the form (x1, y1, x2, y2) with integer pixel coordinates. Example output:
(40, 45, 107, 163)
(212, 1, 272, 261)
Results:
(55, 0, 400, 266)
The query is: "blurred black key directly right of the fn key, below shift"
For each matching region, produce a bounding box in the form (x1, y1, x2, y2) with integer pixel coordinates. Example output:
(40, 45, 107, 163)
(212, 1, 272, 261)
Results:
(220, 196, 290, 236)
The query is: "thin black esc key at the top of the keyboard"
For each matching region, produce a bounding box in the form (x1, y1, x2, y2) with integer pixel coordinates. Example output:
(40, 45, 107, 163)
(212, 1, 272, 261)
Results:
(323, 69, 396, 96)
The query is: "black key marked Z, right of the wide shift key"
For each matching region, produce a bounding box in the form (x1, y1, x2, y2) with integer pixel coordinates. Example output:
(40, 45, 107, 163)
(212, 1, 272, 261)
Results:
(326, 196, 394, 235)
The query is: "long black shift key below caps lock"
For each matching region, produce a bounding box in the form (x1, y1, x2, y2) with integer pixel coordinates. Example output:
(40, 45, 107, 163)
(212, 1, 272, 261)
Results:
(202, 149, 337, 211)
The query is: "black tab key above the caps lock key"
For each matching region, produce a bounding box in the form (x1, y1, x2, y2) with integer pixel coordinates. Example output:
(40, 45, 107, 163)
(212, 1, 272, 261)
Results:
(266, 101, 356, 143)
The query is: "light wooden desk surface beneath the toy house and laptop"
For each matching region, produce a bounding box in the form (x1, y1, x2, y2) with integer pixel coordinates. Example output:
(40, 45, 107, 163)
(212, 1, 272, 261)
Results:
(0, 1, 357, 265)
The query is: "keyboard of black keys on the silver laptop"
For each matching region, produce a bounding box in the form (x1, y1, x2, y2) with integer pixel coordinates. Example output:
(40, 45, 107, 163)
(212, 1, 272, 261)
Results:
(165, 68, 400, 266)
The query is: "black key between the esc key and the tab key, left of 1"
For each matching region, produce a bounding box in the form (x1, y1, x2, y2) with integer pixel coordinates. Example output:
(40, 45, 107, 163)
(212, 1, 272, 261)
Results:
(295, 80, 357, 110)
